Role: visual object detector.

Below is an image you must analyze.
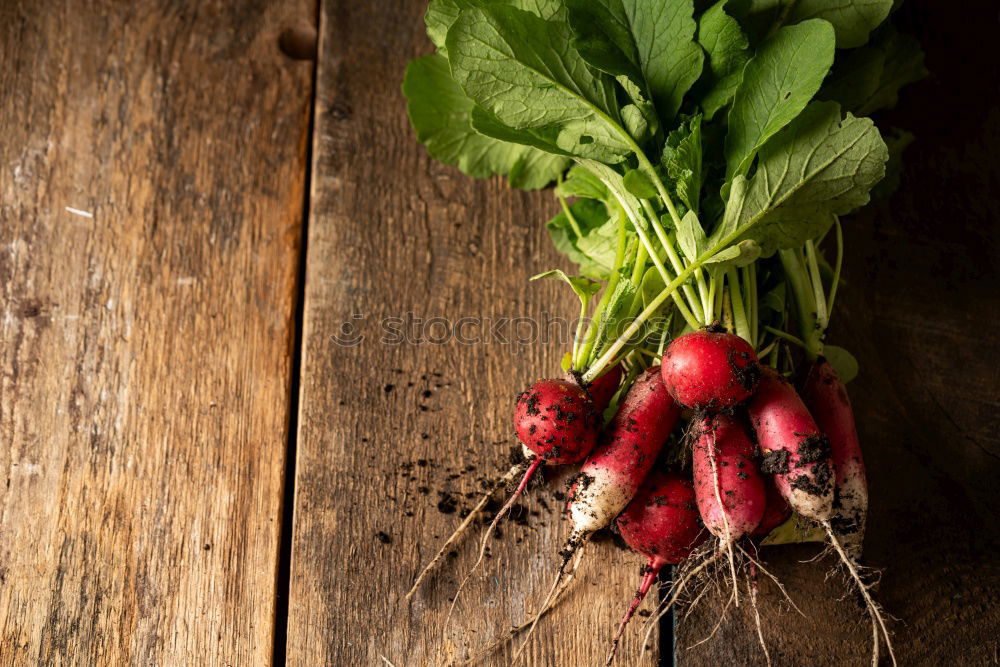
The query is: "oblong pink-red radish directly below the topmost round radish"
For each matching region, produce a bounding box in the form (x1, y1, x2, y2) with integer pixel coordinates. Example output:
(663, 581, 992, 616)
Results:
(691, 414, 766, 542)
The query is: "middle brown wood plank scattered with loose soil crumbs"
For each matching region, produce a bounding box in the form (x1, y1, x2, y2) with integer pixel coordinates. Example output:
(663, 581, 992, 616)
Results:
(288, 0, 664, 665)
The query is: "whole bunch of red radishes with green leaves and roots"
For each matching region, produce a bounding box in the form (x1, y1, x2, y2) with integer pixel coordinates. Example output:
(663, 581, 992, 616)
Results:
(403, 0, 924, 658)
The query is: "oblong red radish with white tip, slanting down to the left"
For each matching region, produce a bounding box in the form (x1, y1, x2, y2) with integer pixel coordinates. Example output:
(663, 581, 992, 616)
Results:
(567, 366, 681, 536)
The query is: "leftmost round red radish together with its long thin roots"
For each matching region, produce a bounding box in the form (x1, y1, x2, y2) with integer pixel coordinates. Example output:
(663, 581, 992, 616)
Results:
(404, 373, 596, 604)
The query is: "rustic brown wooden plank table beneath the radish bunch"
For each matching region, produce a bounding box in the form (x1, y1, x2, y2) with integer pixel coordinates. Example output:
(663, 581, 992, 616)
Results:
(0, 0, 1000, 667)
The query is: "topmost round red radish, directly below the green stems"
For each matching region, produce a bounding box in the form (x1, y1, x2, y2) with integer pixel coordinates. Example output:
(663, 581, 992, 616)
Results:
(662, 328, 760, 410)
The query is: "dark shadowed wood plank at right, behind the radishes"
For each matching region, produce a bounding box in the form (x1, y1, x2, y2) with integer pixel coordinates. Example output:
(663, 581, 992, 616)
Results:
(678, 0, 1000, 665)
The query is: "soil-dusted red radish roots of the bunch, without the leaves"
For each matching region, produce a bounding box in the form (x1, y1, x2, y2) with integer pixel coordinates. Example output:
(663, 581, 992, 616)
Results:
(402, 320, 891, 662)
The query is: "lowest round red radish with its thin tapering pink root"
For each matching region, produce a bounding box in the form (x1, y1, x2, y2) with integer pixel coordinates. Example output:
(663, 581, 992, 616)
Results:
(607, 470, 707, 664)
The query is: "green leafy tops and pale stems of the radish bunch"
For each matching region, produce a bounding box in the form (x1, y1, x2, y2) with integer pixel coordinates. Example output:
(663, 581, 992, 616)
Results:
(403, 0, 924, 379)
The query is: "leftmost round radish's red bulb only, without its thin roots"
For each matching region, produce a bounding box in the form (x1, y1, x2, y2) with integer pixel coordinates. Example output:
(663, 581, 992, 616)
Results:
(514, 380, 601, 464)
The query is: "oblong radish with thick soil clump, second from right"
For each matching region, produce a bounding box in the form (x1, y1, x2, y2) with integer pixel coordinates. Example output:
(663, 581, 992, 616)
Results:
(747, 367, 833, 521)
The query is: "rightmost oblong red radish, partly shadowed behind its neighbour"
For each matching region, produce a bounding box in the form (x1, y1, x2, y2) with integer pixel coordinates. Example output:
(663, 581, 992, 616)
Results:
(802, 357, 868, 559)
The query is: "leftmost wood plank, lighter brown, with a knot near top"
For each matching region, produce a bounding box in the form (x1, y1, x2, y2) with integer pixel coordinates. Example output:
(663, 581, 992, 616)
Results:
(0, 0, 311, 665)
